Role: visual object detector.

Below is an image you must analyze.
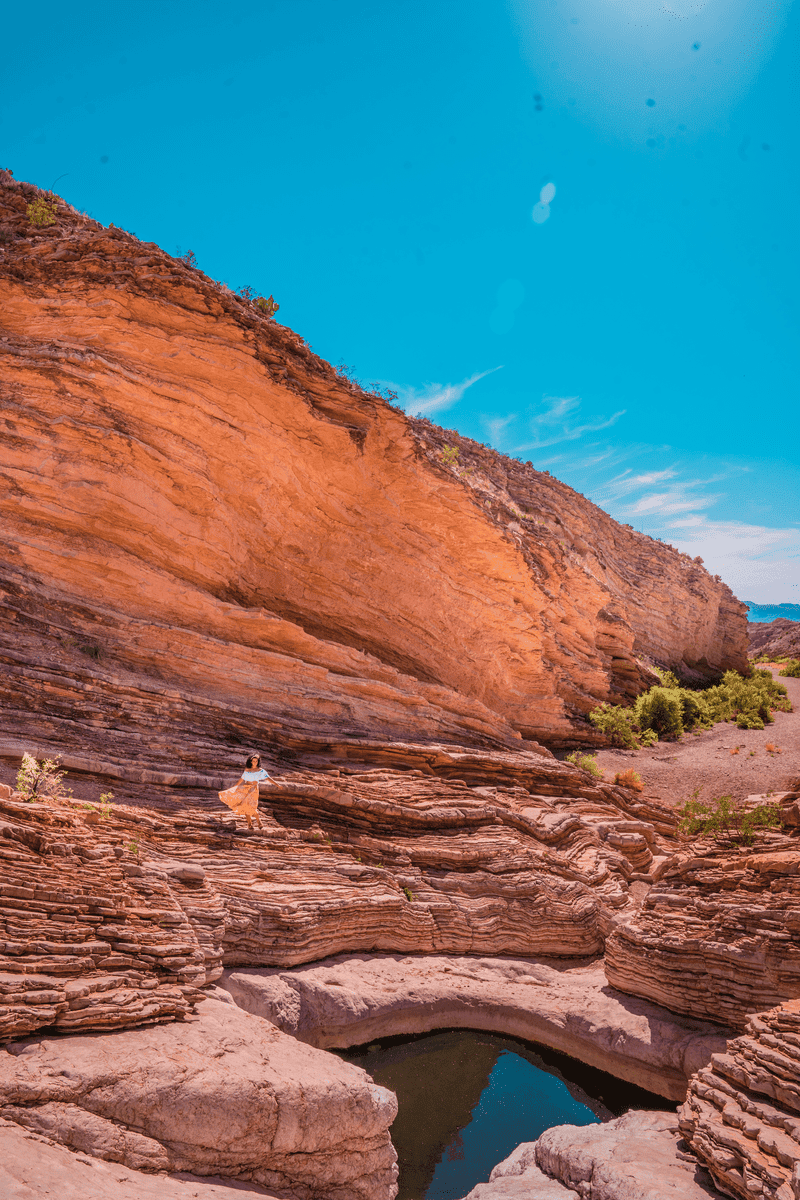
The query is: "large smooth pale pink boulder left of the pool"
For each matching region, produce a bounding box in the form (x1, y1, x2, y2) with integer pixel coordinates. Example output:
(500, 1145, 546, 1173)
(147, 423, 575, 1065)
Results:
(0, 1000, 397, 1200)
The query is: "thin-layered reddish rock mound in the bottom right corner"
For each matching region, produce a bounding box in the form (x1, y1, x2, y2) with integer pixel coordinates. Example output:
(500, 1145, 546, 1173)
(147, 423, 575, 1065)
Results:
(680, 1000, 800, 1200)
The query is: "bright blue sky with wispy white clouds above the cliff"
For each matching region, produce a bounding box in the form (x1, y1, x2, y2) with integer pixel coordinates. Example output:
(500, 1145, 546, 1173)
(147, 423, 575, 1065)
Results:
(0, 0, 800, 602)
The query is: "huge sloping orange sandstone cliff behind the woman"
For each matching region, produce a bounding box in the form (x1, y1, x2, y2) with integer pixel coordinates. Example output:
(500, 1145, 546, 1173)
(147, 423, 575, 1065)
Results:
(0, 173, 747, 778)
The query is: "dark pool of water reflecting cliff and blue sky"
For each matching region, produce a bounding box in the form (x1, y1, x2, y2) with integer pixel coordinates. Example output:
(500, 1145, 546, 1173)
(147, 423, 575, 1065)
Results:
(339, 1030, 668, 1200)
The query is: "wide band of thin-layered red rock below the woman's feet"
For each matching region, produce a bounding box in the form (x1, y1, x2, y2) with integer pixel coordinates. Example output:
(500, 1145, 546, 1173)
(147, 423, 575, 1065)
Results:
(0, 749, 674, 1039)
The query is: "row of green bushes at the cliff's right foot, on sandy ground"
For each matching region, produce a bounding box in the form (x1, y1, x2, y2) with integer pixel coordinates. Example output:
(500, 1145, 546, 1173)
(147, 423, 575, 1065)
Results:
(589, 668, 792, 750)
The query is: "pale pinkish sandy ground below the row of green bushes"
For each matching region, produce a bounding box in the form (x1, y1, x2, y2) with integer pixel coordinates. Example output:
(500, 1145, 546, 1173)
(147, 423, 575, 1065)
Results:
(597, 664, 800, 805)
